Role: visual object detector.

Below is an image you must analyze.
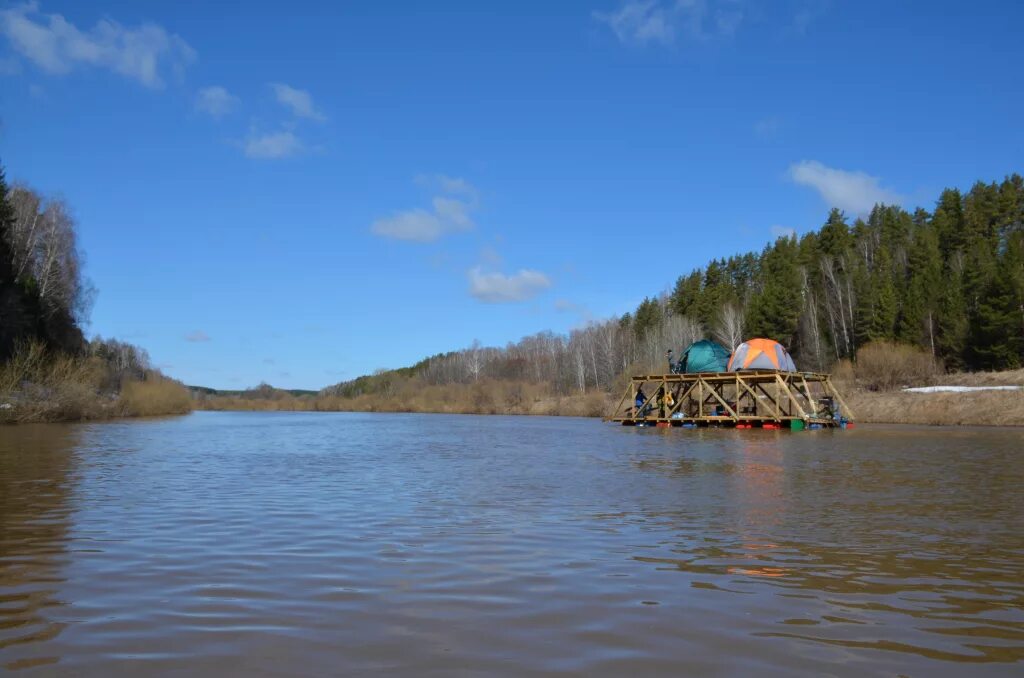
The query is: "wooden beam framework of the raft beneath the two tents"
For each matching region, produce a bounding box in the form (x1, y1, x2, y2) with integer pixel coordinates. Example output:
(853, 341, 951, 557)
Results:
(604, 370, 853, 428)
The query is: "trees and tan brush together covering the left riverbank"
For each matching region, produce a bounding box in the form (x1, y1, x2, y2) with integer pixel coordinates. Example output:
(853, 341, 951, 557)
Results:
(0, 161, 190, 422)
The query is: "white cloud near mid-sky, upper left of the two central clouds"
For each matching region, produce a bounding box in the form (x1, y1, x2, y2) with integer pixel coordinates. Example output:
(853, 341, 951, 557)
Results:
(370, 175, 476, 243)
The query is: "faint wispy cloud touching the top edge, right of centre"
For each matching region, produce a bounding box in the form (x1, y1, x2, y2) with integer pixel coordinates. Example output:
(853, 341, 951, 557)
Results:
(592, 0, 743, 45)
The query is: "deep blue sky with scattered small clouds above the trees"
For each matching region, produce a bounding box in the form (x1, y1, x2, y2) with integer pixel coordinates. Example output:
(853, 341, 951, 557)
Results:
(0, 0, 1024, 388)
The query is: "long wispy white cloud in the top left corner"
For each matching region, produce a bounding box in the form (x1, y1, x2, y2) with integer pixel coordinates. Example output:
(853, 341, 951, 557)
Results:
(0, 2, 196, 88)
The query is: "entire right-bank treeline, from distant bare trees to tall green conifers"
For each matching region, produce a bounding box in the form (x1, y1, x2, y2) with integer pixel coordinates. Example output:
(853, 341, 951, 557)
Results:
(322, 174, 1024, 399)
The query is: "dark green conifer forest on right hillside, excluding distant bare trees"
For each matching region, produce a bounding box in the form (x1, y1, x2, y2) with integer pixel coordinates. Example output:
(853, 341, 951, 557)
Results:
(667, 174, 1024, 371)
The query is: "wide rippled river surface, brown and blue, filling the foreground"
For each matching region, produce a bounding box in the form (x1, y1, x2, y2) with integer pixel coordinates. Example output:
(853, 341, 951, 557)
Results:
(0, 413, 1024, 676)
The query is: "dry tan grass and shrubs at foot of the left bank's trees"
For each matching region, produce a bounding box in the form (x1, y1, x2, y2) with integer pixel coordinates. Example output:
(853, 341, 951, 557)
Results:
(0, 343, 191, 423)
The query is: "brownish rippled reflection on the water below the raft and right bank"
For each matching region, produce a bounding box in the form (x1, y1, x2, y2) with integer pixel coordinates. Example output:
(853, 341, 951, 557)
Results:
(622, 428, 1024, 663)
